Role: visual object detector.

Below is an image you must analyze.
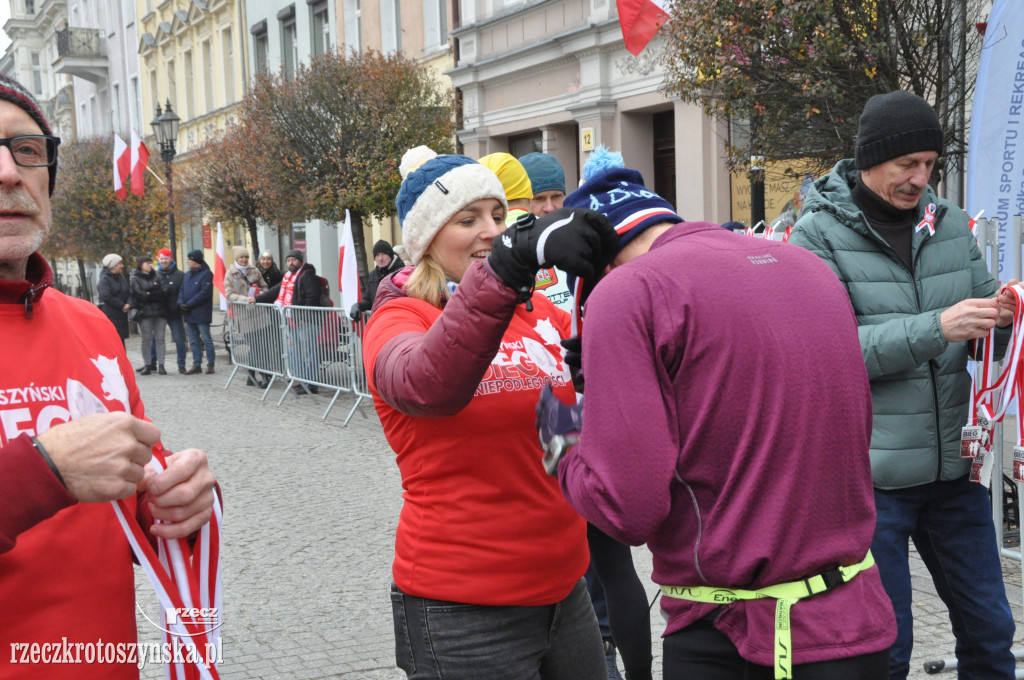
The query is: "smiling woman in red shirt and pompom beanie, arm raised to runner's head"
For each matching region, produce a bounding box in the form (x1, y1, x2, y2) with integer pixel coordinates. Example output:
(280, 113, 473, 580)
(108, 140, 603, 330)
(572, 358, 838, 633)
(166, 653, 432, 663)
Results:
(364, 146, 614, 680)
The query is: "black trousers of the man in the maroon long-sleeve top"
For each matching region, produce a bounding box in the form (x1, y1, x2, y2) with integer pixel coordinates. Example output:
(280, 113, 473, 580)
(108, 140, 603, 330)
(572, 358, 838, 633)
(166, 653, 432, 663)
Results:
(664, 611, 889, 680)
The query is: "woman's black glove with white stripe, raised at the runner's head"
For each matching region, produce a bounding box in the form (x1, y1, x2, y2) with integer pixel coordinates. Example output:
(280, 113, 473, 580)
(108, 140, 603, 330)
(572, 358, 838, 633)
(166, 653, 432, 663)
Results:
(488, 208, 618, 300)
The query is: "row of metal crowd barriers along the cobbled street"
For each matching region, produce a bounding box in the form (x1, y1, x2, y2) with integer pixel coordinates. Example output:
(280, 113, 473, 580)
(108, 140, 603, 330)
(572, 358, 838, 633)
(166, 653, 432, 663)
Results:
(224, 302, 370, 425)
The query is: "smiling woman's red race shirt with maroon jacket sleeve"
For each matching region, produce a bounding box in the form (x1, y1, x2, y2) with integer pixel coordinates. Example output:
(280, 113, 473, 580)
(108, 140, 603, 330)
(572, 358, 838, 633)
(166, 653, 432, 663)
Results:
(364, 263, 589, 605)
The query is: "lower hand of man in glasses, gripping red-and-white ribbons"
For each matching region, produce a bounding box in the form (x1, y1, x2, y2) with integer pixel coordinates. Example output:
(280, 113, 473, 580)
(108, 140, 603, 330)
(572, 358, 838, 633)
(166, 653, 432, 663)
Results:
(139, 449, 214, 539)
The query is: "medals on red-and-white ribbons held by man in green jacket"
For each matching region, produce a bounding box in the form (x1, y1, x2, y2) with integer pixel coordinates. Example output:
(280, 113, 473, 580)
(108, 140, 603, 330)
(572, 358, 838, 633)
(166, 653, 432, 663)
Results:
(961, 285, 1024, 486)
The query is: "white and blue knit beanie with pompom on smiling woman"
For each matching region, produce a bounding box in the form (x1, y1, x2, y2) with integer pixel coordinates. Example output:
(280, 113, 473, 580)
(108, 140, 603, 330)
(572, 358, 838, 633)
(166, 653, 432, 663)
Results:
(394, 146, 508, 264)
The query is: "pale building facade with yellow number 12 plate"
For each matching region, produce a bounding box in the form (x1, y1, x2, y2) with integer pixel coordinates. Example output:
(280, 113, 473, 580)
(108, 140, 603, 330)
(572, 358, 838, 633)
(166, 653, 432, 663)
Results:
(449, 0, 729, 221)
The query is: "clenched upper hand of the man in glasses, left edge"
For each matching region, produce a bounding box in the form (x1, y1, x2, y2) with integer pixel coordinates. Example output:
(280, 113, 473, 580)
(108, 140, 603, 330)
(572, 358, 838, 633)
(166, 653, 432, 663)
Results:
(37, 412, 160, 503)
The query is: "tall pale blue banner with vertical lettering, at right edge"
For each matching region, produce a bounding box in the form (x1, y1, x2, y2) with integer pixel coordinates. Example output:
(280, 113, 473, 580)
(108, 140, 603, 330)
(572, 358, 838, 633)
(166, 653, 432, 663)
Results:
(966, 0, 1024, 282)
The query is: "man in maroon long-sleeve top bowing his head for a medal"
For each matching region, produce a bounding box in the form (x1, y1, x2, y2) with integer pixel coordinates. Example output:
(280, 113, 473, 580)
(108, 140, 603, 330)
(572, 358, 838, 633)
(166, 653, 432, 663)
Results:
(558, 169, 896, 679)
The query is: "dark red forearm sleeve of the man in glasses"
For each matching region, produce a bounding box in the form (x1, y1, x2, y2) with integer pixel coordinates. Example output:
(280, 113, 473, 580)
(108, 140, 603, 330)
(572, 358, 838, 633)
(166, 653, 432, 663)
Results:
(0, 434, 77, 553)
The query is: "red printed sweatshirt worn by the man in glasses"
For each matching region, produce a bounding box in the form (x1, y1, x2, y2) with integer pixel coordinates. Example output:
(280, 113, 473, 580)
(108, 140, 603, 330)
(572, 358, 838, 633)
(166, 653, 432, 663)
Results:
(0, 255, 150, 680)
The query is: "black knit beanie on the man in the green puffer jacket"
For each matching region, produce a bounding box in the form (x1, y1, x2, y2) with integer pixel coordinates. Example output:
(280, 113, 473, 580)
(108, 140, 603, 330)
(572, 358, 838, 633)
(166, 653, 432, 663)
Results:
(854, 90, 942, 170)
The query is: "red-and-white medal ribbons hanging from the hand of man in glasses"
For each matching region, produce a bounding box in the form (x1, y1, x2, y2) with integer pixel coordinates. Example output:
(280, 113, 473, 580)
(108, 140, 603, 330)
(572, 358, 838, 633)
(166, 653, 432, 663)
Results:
(113, 447, 223, 680)
